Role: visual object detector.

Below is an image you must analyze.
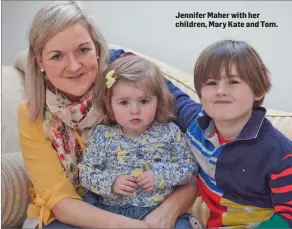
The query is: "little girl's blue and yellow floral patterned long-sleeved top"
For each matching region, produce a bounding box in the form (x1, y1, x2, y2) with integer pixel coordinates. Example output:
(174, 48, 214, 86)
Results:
(79, 122, 198, 207)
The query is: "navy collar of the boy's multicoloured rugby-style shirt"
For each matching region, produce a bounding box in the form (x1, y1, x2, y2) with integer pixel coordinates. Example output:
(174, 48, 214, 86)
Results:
(198, 107, 267, 140)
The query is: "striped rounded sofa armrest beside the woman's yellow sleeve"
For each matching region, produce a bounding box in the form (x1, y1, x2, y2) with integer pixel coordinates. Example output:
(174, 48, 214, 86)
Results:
(1, 152, 31, 228)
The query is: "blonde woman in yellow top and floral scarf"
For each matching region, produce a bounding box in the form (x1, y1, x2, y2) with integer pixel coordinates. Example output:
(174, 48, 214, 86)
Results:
(19, 2, 197, 228)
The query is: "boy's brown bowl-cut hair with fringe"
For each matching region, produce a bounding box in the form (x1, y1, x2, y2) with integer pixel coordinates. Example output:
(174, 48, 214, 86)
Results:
(194, 40, 271, 106)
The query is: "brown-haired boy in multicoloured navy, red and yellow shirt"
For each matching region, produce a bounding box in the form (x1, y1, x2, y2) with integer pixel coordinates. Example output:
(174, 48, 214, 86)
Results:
(168, 40, 292, 228)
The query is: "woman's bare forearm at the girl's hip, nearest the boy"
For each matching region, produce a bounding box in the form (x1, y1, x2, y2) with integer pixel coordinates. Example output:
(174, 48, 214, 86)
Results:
(143, 183, 198, 228)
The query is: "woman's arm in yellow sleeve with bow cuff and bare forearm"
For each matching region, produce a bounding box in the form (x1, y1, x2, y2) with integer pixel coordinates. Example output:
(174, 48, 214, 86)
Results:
(18, 103, 147, 228)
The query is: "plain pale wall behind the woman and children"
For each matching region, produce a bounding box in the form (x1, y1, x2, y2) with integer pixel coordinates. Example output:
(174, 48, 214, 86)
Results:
(2, 1, 292, 112)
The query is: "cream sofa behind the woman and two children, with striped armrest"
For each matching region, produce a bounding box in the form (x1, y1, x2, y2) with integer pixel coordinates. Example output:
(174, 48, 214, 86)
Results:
(1, 44, 292, 228)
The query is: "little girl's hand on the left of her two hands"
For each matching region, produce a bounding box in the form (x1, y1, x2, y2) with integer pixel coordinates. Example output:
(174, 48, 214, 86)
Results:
(112, 175, 138, 197)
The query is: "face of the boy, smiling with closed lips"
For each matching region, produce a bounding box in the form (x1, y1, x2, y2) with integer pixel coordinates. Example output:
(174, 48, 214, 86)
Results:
(201, 65, 263, 123)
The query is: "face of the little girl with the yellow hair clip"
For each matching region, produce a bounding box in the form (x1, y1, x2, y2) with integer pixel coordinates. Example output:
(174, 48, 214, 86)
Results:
(111, 80, 157, 137)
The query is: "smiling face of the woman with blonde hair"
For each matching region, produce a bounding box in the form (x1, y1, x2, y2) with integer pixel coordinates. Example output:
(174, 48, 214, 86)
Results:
(37, 23, 98, 101)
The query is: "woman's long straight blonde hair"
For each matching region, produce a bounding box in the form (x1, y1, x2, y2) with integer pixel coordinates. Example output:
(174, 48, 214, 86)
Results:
(26, 1, 108, 120)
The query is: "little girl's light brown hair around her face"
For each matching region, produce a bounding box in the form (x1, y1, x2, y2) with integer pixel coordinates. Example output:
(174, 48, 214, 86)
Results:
(94, 55, 174, 124)
